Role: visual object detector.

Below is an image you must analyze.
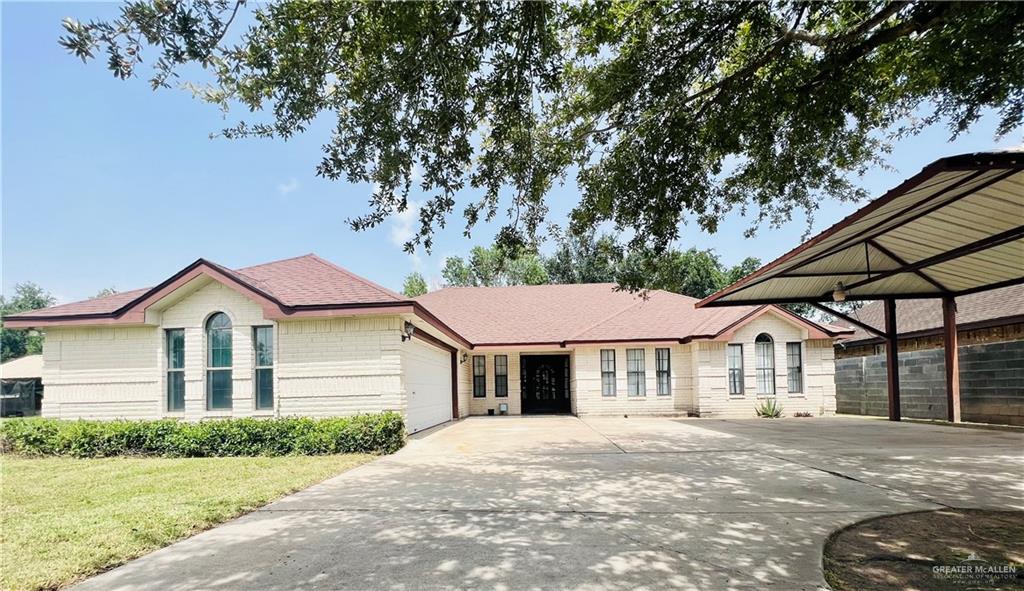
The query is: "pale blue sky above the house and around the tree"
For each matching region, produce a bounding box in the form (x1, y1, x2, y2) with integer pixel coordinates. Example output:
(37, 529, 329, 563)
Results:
(0, 2, 1021, 302)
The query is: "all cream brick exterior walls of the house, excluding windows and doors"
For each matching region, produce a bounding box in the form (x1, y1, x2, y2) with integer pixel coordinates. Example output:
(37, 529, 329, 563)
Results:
(37, 279, 835, 420)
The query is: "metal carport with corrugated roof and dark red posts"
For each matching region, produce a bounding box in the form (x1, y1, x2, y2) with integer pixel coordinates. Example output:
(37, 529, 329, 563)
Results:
(697, 151, 1024, 422)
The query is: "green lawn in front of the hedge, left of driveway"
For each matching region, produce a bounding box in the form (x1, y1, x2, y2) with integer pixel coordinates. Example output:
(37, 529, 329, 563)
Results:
(0, 455, 373, 589)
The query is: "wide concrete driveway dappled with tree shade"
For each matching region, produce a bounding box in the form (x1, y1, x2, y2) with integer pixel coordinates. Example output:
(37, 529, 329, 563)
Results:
(78, 417, 1024, 590)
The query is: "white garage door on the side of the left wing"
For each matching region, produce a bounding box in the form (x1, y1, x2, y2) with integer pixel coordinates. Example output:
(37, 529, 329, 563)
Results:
(404, 338, 452, 433)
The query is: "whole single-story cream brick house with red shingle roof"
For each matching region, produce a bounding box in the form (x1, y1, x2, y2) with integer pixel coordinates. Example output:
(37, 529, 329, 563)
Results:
(4, 255, 849, 431)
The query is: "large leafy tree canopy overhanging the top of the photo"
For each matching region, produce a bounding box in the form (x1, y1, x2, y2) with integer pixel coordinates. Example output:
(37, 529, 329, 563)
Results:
(60, 0, 1024, 288)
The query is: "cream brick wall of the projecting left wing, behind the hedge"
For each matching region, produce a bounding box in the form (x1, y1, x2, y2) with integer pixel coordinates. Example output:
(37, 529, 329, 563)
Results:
(43, 280, 404, 420)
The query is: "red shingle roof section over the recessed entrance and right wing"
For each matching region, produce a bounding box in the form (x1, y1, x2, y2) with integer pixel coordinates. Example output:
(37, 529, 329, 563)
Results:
(416, 284, 847, 346)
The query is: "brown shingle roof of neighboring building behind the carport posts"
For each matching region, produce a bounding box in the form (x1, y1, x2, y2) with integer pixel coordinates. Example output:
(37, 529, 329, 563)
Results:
(843, 285, 1024, 344)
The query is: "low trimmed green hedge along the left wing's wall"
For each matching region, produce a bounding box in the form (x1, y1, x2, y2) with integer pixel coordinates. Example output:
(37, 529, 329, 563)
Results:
(0, 412, 406, 458)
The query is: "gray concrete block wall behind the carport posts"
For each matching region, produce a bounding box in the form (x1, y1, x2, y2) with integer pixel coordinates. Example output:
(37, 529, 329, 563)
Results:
(836, 340, 1024, 425)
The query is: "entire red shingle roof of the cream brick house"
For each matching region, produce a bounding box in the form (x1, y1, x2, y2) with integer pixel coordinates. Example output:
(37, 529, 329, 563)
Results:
(7, 254, 836, 345)
